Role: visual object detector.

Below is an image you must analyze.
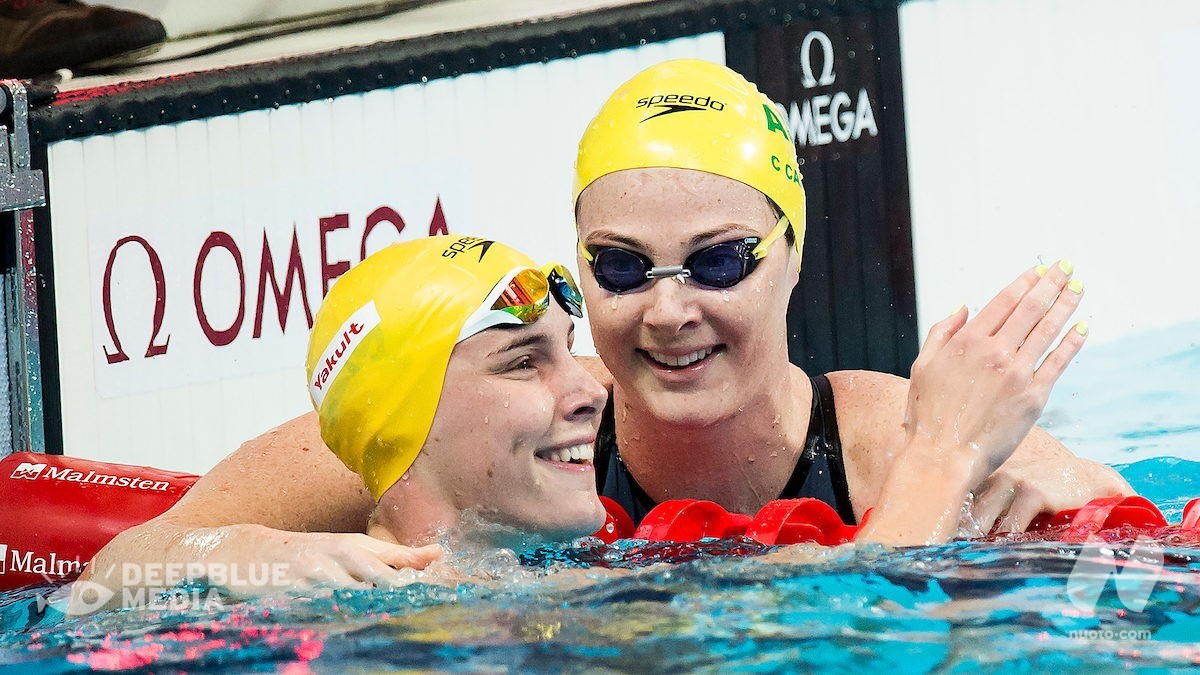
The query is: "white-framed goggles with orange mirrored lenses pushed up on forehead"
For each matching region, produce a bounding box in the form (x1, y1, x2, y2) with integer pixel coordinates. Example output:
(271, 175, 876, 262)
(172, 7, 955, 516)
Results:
(455, 263, 583, 344)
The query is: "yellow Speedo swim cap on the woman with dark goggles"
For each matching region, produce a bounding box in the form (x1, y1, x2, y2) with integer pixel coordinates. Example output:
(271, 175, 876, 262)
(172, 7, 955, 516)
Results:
(574, 59, 804, 251)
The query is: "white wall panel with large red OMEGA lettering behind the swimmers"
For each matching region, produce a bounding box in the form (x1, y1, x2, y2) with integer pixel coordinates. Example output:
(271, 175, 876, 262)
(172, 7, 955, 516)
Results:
(49, 34, 725, 472)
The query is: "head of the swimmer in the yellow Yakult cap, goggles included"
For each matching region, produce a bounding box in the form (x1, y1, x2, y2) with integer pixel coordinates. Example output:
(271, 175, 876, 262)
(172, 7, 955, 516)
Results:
(306, 235, 604, 544)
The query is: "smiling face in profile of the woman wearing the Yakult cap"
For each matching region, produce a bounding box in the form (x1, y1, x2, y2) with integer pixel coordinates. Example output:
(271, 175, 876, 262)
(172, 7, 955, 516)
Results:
(410, 303, 606, 539)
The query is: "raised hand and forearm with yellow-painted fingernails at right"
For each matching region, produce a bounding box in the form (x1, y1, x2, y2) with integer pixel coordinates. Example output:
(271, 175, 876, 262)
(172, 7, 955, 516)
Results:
(858, 261, 1087, 545)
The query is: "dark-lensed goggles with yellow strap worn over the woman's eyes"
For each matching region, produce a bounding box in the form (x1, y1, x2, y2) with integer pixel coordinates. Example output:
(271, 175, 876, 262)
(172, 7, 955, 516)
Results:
(580, 216, 791, 293)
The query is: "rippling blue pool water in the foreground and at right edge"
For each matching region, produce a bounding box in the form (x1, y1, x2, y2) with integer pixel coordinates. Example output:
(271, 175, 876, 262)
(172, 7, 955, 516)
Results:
(0, 327, 1200, 673)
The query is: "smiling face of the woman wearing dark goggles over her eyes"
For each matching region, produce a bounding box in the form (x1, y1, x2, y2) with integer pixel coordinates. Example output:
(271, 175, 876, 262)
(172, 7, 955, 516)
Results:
(577, 168, 799, 425)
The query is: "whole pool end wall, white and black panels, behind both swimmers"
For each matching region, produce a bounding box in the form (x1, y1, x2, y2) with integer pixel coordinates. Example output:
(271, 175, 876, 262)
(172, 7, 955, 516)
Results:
(7, 0, 1200, 472)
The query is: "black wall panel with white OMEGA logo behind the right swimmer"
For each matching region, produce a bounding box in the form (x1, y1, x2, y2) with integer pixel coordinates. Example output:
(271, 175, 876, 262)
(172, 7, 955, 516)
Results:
(726, 8, 918, 375)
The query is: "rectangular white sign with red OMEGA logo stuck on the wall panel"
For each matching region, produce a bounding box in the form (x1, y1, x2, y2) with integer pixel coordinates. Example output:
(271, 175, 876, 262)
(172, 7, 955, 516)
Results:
(89, 165, 463, 398)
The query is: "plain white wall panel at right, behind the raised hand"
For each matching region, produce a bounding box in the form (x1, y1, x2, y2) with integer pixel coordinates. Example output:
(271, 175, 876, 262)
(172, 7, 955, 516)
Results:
(900, 0, 1200, 341)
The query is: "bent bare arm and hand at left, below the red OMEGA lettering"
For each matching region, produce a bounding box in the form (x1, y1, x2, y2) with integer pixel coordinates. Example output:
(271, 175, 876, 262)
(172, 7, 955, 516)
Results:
(72, 413, 440, 614)
